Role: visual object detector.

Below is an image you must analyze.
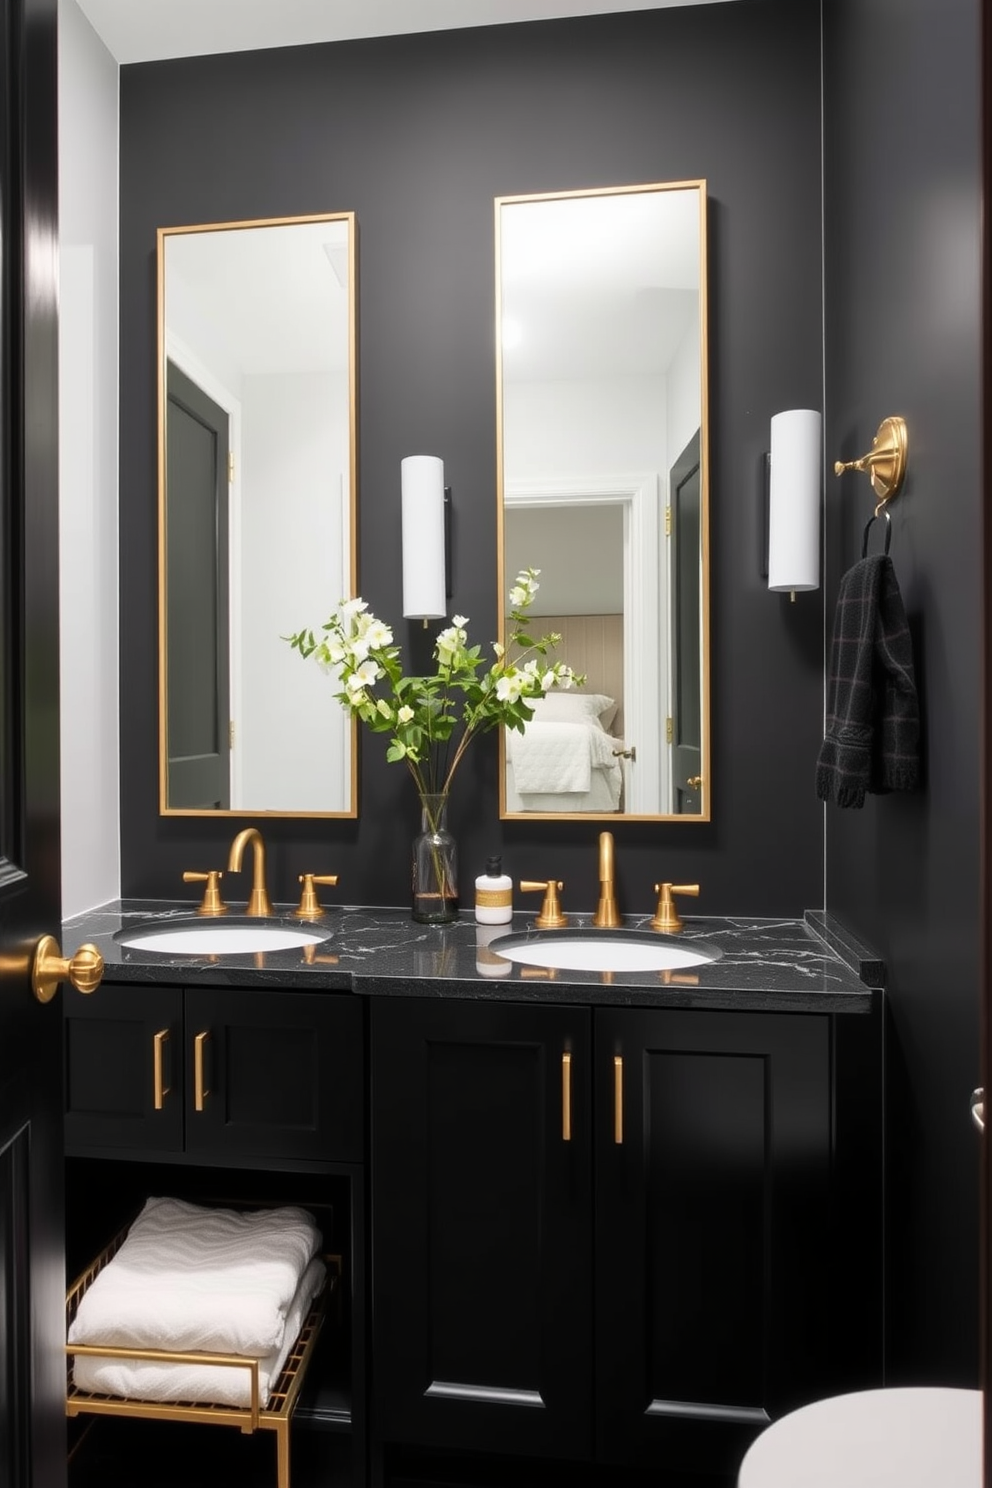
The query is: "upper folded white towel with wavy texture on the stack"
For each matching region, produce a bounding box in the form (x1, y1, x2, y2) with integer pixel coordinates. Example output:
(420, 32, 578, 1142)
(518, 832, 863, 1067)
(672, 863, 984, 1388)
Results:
(68, 1198, 321, 1359)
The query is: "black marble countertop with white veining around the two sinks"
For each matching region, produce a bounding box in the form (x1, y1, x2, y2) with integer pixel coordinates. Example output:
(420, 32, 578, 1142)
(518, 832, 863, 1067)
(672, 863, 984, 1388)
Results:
(62, 899, 883, 1013)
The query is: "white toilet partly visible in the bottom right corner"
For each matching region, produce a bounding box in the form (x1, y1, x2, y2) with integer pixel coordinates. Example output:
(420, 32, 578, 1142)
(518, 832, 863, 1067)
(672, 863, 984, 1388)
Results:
(738, 1388, 983, 1488)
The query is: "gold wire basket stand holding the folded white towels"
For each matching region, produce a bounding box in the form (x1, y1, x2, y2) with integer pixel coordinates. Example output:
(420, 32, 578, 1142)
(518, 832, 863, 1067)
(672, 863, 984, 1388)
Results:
(65, 1226, 342, 1488)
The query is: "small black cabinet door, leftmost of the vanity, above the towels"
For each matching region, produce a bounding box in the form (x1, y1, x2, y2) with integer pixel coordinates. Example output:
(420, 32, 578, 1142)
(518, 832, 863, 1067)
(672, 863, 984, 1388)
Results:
(62, 984, 183, 1156)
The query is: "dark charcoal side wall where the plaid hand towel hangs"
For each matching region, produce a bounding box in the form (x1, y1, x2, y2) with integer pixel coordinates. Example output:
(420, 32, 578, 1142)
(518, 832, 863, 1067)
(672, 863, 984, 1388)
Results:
(824, 0, 982, 1385)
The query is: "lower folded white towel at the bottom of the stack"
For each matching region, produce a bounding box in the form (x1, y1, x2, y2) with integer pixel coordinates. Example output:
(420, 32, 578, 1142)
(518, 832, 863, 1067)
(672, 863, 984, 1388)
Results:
(73, 1257, 327, 1408)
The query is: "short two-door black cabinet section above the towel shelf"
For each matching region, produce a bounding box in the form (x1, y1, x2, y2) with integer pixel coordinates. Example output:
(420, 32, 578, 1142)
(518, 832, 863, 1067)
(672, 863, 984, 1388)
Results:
(64, 985, 364, 1162)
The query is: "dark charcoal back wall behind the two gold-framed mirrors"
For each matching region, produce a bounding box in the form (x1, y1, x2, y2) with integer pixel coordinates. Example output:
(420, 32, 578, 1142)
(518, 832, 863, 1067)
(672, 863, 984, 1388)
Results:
(120, 0, 822, 915)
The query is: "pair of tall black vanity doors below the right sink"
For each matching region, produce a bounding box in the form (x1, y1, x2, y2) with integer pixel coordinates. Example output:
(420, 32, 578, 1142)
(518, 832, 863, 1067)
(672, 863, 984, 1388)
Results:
(372, 998, 867, 1470)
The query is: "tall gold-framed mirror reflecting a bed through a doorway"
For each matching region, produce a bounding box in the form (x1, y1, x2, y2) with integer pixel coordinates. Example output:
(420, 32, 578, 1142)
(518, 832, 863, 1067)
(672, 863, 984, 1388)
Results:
(495, 180, 709, 821)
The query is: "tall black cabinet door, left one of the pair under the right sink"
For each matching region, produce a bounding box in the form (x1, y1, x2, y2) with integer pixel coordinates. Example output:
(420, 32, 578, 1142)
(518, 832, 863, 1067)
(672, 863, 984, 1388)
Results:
(370, 998, 593, 1458)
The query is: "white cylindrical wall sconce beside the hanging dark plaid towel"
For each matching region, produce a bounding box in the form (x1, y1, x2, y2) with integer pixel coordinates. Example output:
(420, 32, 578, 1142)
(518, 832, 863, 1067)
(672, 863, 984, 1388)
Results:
(767, 408, 822, 594)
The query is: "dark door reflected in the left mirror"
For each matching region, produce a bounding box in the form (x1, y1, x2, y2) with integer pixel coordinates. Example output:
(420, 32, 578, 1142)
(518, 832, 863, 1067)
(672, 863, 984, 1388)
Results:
(165, 362, 231, 811)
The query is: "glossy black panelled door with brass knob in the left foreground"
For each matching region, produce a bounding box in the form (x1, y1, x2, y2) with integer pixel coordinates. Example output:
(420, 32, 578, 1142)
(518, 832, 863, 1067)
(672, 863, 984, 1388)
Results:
(0, 0, 65, 1488)
